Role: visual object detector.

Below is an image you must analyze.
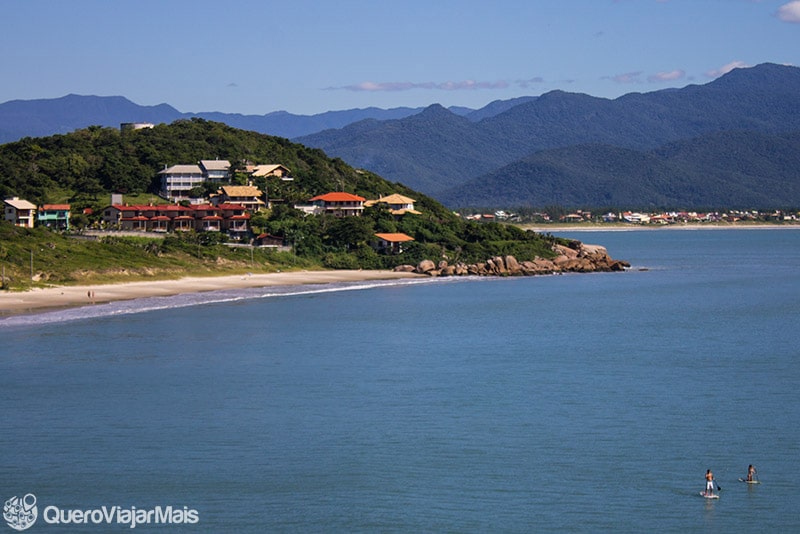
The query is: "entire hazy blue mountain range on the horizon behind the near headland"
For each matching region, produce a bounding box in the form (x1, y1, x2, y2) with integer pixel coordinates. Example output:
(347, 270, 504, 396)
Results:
(0, 63, 800, 208)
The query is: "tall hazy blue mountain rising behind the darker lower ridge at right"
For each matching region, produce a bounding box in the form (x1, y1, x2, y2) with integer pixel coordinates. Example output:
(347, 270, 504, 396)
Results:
(299, 64, 800, 207)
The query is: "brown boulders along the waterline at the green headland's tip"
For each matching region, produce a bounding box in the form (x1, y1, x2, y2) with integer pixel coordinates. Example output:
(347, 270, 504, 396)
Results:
(394, 241, 630, 276)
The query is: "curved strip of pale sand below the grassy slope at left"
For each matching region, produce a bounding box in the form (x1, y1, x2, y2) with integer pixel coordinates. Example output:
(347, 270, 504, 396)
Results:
(0, 270, 423, 316)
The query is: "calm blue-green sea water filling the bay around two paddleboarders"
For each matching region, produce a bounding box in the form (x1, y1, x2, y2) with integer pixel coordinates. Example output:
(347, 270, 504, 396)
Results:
(0, 230, 800, 532)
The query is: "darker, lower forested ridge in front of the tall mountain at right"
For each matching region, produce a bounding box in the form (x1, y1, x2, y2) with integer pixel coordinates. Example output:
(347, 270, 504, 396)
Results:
(437, 131, 800, 210)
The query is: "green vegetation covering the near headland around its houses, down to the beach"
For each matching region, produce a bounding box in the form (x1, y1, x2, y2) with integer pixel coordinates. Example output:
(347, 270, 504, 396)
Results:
(0, 119, 552, 292)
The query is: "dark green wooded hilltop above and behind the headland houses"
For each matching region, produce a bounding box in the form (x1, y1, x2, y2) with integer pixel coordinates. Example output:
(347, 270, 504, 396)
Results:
(0, 119, 418, 207)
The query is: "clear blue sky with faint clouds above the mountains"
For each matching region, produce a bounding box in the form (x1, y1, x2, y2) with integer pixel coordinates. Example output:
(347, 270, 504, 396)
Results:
(0, 0, 800, 115)
